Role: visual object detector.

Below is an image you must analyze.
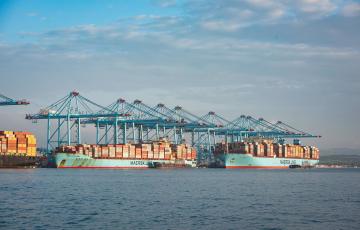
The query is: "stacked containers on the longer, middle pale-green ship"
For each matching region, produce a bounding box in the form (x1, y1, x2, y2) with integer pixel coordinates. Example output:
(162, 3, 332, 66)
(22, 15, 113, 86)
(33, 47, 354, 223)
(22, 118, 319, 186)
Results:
(55, 141, 196, 160)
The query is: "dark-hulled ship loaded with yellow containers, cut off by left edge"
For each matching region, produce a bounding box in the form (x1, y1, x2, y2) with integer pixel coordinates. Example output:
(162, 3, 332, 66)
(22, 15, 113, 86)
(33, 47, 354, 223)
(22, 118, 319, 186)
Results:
(0, 131, 41, 168)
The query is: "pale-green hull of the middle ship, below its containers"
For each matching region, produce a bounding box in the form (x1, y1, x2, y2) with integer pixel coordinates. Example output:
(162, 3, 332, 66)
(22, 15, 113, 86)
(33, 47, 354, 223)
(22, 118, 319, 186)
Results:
(54, 153, 193, 169)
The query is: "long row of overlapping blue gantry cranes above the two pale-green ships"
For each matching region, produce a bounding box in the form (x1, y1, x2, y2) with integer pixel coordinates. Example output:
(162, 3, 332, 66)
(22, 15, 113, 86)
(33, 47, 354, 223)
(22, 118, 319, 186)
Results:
(26, 91, 320, 161)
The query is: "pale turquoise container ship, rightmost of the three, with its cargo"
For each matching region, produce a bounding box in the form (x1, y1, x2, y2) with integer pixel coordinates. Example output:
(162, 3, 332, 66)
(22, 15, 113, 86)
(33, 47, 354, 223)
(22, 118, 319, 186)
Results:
(214, 141, 319, 169)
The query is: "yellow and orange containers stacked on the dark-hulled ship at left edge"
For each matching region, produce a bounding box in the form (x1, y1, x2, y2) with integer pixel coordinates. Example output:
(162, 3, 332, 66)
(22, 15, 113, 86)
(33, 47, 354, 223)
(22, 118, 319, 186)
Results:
(0, 131, 36, 156)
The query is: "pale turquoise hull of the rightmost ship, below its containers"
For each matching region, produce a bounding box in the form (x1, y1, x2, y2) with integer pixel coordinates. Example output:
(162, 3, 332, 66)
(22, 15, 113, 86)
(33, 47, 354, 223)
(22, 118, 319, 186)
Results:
(216, 153, 319, 169)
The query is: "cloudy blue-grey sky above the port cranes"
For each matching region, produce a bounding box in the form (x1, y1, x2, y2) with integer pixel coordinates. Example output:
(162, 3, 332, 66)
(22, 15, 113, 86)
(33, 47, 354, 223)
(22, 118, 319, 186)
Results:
(0, 0, 360, 149)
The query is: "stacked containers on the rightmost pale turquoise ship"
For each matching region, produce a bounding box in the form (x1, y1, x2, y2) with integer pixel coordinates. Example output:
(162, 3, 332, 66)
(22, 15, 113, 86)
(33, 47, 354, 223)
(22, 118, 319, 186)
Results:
(215, 141, 319, 159)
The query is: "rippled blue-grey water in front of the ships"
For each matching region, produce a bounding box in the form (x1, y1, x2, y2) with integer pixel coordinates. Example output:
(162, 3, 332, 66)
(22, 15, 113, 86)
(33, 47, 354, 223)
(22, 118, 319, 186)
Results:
(0, 169, 360, 229)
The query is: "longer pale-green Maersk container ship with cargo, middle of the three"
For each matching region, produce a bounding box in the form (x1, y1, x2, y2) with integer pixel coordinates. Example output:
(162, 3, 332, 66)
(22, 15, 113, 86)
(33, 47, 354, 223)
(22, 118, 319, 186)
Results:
(52, 138, 196, 169)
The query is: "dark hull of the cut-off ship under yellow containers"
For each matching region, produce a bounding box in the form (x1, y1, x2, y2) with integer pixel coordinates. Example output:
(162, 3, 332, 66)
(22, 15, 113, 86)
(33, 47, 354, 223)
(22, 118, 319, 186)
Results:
(0, 155, 41, 168)
